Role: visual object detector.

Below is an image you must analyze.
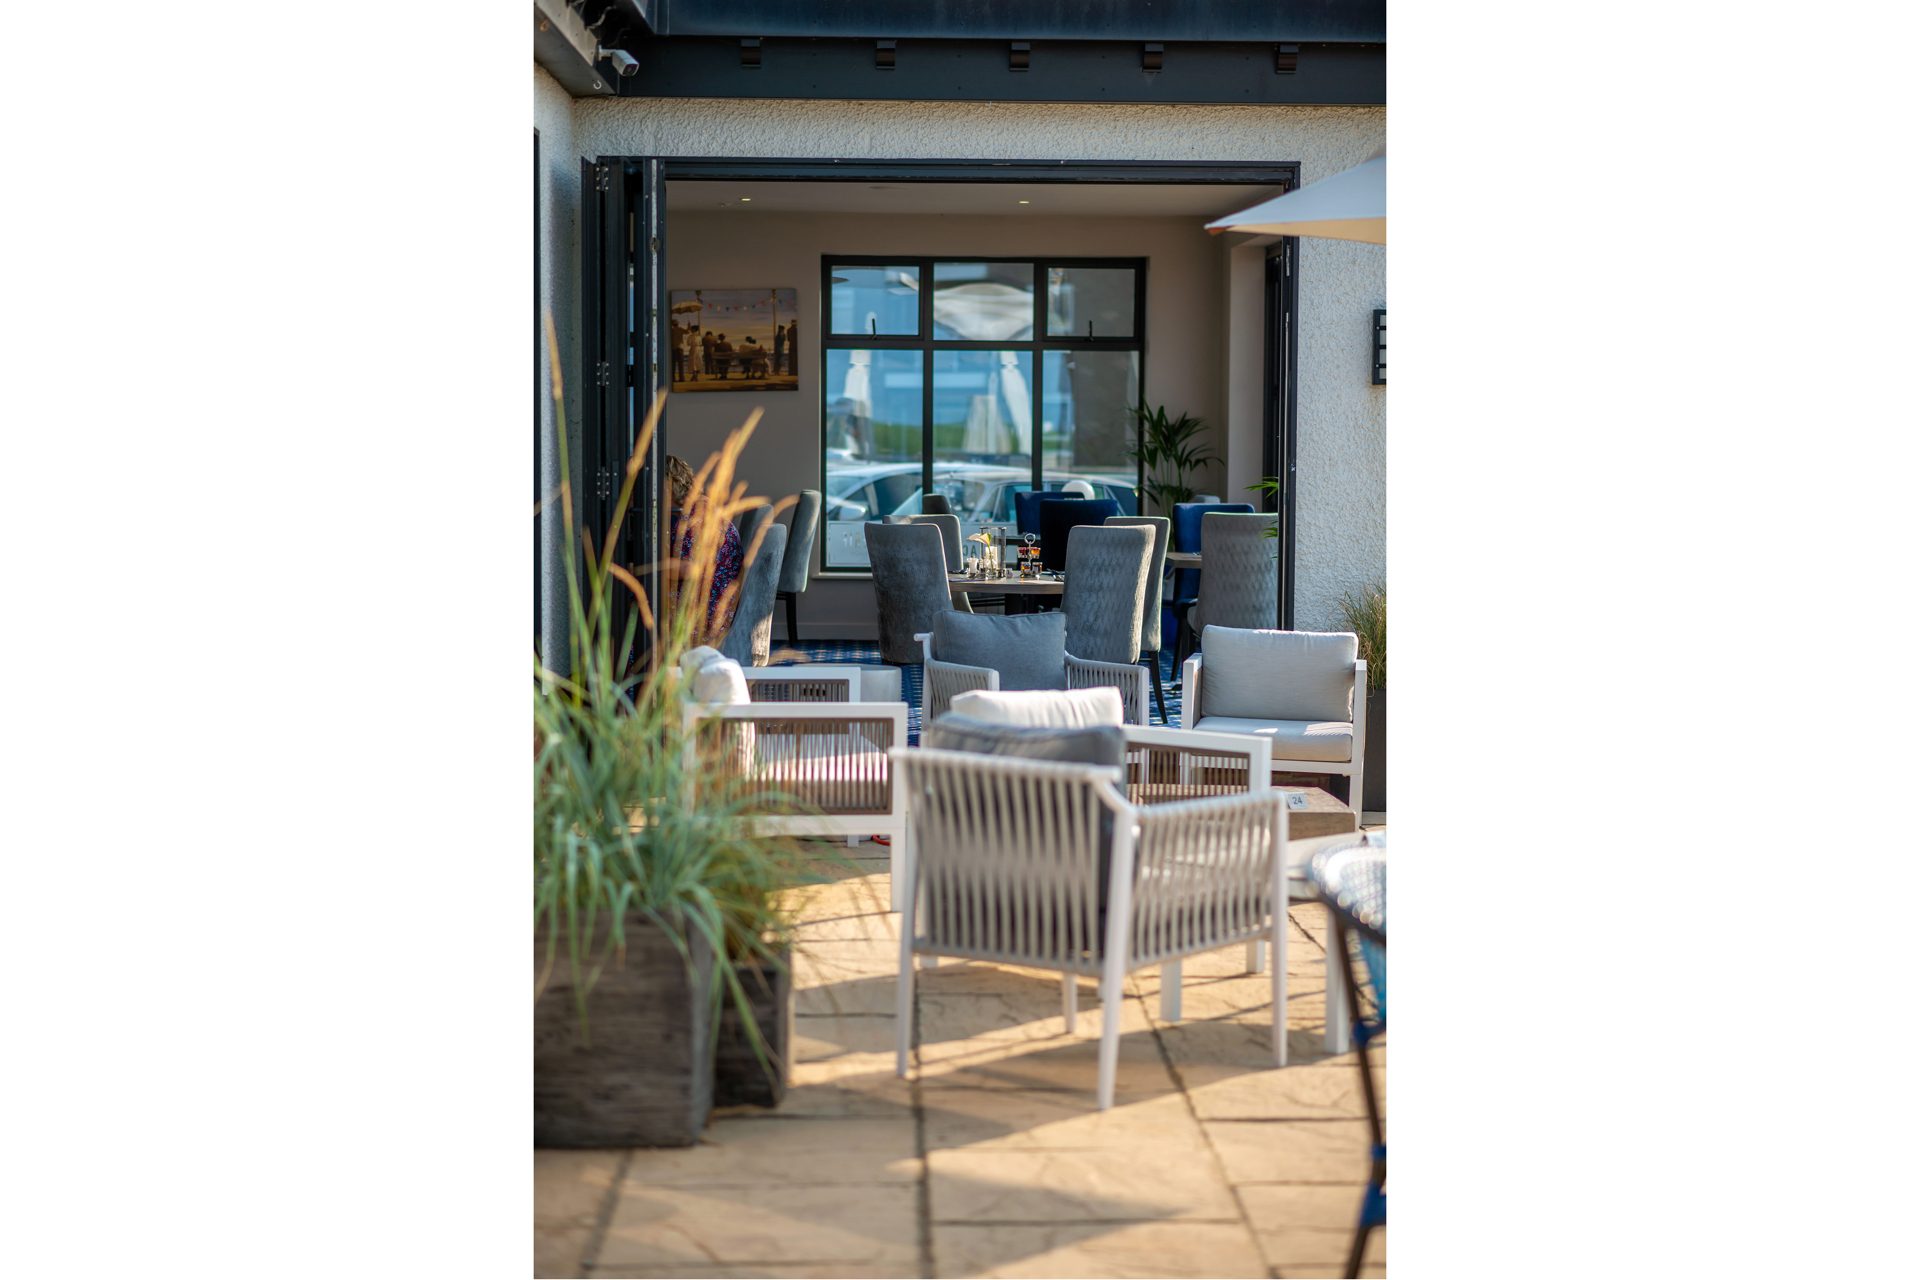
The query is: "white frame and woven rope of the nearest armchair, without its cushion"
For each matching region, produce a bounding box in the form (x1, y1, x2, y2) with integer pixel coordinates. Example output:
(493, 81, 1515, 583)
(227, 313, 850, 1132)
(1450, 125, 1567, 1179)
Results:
(893, 752, 1286, 1111)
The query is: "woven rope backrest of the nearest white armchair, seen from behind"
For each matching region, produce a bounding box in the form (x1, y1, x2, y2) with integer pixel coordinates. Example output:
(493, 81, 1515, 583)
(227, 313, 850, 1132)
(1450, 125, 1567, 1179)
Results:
(900, 750, 1131, 973)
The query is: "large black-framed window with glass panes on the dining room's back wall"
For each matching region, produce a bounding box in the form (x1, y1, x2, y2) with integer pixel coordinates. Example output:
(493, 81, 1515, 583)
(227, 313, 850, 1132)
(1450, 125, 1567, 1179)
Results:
(822, 257, 1146, 570)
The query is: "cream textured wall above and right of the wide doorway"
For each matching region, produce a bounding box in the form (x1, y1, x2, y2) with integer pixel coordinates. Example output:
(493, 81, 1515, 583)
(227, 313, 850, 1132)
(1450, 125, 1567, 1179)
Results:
(572, 98, 1386, 629)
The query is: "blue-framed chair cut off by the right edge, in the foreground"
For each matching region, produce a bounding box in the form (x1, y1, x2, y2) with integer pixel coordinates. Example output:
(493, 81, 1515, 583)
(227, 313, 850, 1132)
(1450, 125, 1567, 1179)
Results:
(1308, 833, 1386, 1276)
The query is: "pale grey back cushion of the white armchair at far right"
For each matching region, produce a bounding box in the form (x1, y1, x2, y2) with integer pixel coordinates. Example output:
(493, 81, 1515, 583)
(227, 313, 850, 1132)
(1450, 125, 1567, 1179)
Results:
(1200, 628, 1359, 725)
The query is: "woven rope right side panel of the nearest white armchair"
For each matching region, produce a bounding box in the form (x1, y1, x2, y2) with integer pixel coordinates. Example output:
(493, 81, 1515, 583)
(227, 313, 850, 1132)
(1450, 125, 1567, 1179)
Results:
(1129, 793, 1283, 965)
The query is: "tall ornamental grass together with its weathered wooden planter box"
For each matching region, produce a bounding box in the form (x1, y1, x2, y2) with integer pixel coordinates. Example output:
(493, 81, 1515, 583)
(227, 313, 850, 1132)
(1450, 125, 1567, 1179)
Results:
(534, 322, 816, 1146)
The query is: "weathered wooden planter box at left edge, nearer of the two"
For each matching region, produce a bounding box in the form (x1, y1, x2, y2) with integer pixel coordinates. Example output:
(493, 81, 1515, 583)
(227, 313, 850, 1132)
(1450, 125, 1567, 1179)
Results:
(534, 917, 714, 1148)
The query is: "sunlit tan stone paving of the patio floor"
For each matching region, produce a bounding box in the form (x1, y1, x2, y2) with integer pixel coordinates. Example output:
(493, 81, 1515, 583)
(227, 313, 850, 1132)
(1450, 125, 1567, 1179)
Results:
(536, 846, 1386, 1280)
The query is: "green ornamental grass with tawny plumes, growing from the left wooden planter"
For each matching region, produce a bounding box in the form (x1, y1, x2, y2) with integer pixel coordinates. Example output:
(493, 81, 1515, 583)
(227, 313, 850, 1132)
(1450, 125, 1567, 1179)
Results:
(534, 317, 851, 1065)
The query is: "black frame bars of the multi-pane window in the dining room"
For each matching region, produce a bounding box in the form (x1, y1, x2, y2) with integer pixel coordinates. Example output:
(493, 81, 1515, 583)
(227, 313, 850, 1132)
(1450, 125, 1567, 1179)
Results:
(814, 253, 1148, 578)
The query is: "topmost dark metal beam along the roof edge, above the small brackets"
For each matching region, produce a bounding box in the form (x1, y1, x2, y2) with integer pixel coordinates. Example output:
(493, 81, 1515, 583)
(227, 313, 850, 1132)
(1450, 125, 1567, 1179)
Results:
(626, 0, 1386, 42)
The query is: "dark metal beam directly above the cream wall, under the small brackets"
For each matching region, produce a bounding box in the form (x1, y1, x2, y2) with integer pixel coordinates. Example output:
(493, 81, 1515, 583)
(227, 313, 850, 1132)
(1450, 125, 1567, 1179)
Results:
(614, 39, 1386, 106)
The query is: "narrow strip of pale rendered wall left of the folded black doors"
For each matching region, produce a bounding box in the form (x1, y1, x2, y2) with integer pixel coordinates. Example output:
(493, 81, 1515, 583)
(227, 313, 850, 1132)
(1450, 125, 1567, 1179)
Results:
(534, 63, 582, 660)
